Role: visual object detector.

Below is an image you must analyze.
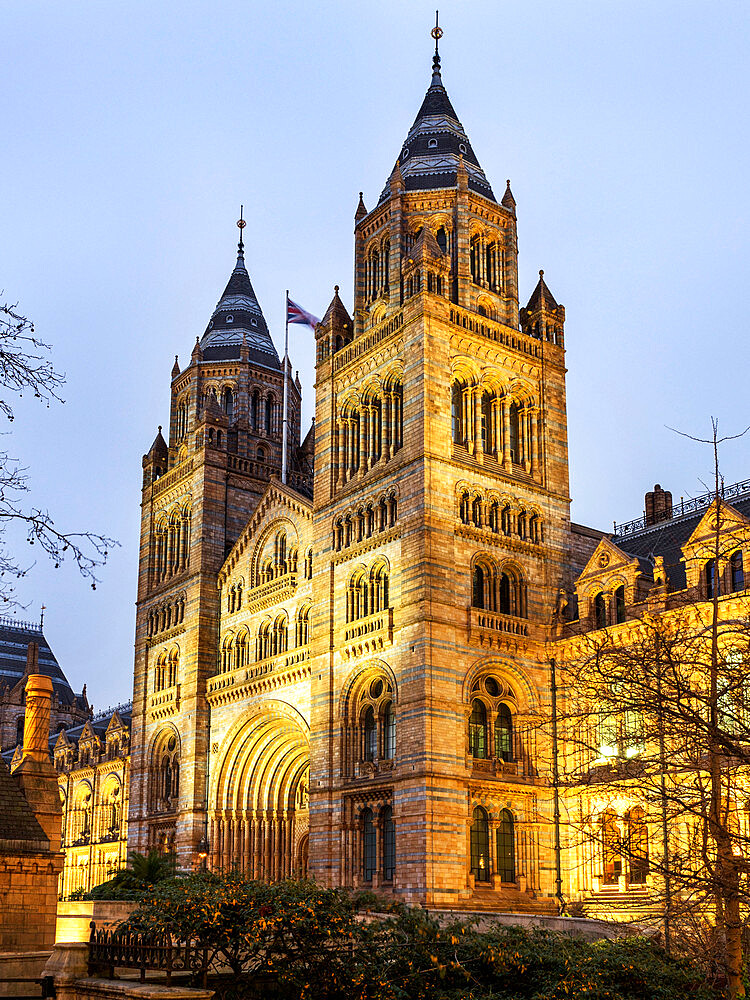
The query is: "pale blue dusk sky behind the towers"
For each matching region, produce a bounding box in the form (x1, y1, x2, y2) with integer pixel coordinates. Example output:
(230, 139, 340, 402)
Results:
(0, 0, 750, 708)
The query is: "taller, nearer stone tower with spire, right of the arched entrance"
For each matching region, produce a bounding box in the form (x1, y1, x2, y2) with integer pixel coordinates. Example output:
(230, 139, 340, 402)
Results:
(310, 29, 569, 909)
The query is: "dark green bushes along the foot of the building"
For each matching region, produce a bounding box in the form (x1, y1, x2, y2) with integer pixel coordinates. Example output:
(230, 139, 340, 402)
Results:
(125, 872, 713, 1000)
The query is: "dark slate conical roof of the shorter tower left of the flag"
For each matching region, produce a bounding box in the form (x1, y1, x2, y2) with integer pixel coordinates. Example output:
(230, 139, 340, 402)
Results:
(200, 241, 281, 368)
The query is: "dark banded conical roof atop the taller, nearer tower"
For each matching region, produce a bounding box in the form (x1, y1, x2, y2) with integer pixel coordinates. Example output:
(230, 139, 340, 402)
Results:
(379, 49, 496, 204)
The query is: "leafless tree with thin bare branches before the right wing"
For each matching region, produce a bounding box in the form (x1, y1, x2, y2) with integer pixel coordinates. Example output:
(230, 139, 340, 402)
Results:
(557, 421, 750, 998)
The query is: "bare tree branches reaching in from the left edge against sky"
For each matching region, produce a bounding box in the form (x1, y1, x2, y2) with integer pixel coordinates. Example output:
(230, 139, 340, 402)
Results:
(0, 302, 118, 606)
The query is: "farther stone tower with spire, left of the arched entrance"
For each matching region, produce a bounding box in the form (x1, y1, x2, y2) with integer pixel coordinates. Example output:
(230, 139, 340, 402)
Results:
(129, 220, 301, 867)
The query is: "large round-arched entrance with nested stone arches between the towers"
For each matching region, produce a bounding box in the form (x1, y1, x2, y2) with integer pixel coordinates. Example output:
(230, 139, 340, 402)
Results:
(209, 702, 310, 882)
